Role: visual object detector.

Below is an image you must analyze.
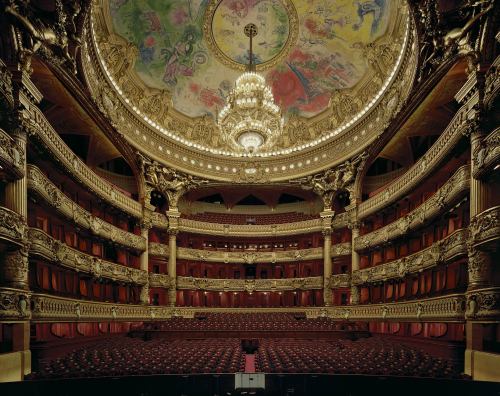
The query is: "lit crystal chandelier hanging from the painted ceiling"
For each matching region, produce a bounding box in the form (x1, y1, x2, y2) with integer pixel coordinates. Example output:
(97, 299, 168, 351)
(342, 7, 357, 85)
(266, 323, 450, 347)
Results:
(217, 23, 283, 153)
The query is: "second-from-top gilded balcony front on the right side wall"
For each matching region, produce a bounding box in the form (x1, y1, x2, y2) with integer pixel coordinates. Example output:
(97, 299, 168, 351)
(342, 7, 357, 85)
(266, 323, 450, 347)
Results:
(354, 165, 470, 251)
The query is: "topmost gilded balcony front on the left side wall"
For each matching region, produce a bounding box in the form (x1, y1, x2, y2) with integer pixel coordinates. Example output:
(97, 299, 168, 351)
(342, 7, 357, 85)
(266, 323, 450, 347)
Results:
(26, 103, 142, 219)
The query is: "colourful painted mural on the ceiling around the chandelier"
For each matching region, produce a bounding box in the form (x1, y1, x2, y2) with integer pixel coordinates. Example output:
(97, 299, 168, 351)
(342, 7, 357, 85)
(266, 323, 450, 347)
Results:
(108, 0, 394, 117)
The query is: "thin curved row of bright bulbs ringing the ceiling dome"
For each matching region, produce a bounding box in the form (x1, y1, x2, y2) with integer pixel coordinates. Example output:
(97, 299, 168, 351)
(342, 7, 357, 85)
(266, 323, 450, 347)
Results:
(90, 8, 411, 158)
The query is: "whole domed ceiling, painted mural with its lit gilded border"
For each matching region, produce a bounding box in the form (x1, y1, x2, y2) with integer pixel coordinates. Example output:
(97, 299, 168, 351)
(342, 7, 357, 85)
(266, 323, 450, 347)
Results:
(87, 0, 418, 182)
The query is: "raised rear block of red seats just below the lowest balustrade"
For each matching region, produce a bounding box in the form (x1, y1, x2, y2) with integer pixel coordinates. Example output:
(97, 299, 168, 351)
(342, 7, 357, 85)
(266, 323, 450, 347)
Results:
(145, 313, 359, 331)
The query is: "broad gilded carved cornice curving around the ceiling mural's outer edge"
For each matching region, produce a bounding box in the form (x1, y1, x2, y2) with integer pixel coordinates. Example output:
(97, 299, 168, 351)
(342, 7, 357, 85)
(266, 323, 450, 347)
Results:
(82, 2, 416, 183)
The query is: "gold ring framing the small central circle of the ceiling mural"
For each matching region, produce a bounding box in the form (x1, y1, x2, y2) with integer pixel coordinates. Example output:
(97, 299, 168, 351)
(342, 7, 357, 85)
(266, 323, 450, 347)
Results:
(203, 0, 299, 72)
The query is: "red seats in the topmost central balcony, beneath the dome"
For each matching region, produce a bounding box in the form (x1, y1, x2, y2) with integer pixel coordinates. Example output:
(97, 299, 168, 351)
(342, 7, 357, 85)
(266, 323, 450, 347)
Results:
(186, 212, 318, 224)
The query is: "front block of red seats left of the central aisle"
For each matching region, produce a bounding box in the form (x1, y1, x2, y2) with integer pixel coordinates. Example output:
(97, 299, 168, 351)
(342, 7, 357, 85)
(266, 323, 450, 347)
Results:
(34, 337, 245, 378)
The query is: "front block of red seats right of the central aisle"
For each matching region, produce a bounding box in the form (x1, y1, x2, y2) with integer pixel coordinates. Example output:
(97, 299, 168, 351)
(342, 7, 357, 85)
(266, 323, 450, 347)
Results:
(256, 337, 459, 378)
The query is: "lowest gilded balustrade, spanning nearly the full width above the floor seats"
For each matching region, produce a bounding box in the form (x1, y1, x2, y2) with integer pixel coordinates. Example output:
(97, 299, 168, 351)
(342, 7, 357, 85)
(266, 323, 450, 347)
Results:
(26, 291, 466, 322)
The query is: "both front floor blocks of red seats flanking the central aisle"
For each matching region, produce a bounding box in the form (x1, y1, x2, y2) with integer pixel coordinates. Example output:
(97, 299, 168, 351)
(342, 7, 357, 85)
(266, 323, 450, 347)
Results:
(32, 336, 459, 379)
